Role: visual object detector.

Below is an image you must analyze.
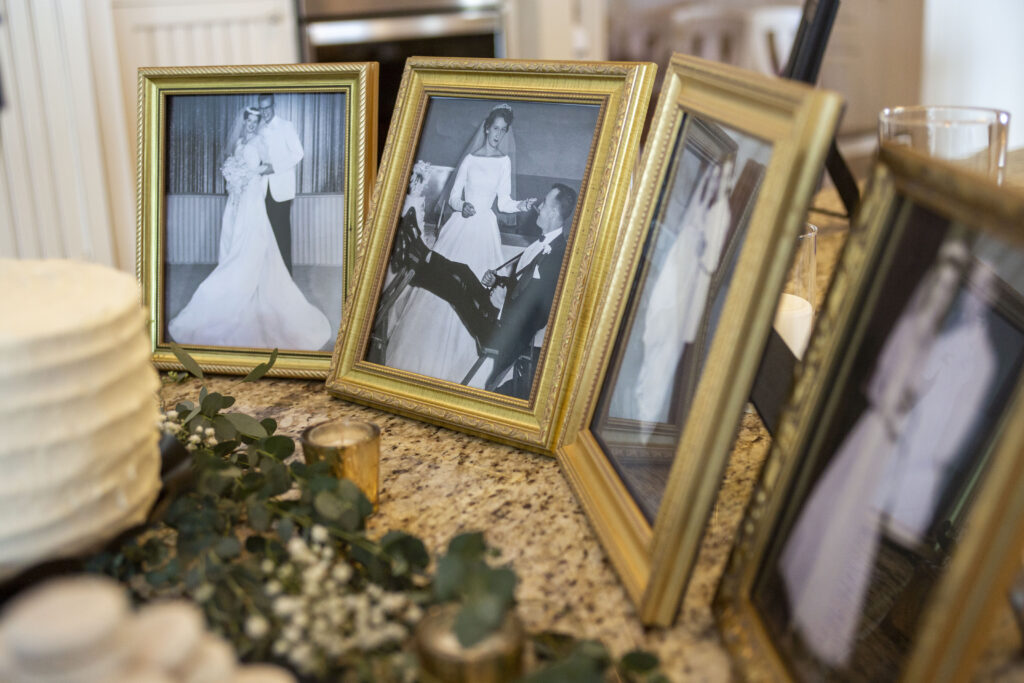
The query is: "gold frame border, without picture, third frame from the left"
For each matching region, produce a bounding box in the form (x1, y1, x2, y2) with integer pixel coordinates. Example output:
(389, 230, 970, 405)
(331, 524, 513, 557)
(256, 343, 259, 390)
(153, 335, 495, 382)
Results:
(558, 54, 841, 625)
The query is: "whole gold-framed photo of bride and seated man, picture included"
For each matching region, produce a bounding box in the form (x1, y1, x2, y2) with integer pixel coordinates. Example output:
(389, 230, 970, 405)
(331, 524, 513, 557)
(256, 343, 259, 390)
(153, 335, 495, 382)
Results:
(327, 57, 655, 454)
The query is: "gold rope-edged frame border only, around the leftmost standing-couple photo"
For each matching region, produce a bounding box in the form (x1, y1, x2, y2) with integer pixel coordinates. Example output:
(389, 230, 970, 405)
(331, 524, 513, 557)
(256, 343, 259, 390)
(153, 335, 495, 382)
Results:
(135, 62, 378, 379)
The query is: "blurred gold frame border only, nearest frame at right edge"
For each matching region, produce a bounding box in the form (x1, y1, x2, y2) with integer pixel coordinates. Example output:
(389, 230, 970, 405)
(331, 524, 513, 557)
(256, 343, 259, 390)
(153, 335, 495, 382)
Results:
(714, 147, 1024, 682)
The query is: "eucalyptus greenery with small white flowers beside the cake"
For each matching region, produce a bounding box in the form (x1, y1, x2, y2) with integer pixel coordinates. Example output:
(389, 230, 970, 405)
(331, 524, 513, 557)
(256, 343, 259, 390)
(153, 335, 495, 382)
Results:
(89, 345, 430, 680)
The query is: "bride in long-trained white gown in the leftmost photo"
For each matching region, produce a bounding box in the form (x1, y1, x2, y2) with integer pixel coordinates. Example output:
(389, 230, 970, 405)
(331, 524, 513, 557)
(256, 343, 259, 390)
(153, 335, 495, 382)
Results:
(168, 106, 331, 351)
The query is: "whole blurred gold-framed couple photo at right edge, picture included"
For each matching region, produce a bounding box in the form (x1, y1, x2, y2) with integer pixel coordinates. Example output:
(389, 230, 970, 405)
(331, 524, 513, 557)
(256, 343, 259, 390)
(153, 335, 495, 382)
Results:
(714, 146, 1024, 683)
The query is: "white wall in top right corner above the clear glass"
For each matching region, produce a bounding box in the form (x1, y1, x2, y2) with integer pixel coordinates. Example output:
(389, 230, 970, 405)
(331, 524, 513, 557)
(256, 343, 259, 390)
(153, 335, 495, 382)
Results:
(921, 0, 1024, 148)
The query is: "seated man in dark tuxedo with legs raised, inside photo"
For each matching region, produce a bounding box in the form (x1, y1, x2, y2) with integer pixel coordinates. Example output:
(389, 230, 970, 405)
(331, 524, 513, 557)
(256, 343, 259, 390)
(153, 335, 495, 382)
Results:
(398, 183, 577, 398)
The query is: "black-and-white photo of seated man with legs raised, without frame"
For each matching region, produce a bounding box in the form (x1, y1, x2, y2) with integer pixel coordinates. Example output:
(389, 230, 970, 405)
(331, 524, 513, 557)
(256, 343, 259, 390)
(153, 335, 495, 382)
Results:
(367, 96, 600, 398)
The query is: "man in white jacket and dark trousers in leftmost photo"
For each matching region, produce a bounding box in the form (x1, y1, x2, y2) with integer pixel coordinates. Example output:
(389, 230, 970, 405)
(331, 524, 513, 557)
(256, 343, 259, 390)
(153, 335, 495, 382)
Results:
(259, 93, 303, 273)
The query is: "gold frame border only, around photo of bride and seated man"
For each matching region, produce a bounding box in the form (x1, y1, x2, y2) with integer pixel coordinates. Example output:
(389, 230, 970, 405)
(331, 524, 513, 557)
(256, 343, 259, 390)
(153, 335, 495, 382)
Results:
(327, 57, 655, 454)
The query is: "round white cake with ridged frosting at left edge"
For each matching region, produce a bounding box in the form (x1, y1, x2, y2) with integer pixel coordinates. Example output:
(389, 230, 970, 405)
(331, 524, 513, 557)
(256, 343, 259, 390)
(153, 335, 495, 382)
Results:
(0, 259, 160, 578)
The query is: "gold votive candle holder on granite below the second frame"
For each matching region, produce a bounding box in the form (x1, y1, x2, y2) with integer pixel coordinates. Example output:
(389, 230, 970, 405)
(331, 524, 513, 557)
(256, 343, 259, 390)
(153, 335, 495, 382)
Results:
(300, 419, 381, 511)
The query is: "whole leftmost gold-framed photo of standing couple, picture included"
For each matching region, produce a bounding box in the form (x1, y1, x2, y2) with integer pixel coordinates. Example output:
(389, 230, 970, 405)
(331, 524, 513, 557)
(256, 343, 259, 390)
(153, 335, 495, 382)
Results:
(135, 62, 378, 379)
